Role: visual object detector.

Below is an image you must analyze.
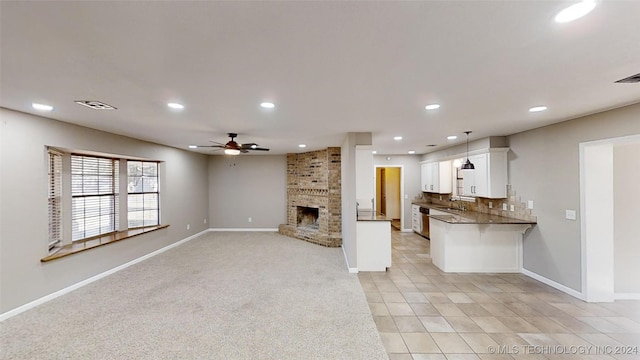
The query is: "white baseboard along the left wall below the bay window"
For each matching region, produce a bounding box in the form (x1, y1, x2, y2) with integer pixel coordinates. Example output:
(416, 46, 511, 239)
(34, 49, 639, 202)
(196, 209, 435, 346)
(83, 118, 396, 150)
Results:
(0, 230, 207, 322)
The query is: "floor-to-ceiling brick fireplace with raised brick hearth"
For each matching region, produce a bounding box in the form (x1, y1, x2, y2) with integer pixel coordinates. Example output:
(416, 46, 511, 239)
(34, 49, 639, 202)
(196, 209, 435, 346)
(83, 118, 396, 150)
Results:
(278, 147, 342, 247)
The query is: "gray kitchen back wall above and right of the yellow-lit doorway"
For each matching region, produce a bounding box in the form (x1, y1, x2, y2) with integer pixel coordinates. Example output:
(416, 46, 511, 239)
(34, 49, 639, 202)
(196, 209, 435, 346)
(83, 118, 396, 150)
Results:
(373, 155, 422, 230)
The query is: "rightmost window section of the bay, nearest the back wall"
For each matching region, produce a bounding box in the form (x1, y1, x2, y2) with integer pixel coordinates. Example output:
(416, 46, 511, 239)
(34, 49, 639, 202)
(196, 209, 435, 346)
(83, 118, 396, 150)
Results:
(127, 161, 160, 228)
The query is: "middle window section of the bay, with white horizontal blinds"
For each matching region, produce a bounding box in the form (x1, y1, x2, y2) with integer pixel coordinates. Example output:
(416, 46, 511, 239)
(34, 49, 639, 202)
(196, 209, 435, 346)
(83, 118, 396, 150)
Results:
(71, 155, 119, 241)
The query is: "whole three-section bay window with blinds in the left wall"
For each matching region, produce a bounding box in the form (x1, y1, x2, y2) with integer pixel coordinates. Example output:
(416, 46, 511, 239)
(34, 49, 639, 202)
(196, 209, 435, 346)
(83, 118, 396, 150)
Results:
(47, 148, 163, 255)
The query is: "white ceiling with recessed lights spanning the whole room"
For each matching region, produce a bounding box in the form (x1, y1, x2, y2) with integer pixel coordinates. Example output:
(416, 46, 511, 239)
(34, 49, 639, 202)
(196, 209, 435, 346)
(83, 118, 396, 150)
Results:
(0, 1, 640, 154)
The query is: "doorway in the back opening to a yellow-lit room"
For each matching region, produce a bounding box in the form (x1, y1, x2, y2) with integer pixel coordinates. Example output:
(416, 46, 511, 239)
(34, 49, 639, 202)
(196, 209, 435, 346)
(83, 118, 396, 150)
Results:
(375, 166, 403, 231)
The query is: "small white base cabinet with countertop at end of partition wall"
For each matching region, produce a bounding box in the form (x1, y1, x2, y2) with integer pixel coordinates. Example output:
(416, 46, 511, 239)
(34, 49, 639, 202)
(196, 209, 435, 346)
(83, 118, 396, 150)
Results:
(356, 210, 391, 271)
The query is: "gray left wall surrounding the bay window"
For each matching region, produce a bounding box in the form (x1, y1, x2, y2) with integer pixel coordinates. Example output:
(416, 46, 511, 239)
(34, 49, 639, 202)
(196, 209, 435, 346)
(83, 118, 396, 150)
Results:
(0, 108, 208, 313)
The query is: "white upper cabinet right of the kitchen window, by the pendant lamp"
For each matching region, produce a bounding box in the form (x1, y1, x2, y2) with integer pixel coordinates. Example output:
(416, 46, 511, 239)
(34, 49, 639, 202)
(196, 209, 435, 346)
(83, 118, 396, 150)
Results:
(461, 148, 509, 199)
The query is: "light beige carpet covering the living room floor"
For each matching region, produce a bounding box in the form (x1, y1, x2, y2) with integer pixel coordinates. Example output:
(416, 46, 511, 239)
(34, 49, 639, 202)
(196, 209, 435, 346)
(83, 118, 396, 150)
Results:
(0, 232, 388, 360)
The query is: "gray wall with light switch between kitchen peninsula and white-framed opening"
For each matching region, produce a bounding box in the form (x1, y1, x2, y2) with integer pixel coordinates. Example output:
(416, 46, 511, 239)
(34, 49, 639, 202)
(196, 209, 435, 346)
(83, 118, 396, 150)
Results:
(508, 104, 640, 292)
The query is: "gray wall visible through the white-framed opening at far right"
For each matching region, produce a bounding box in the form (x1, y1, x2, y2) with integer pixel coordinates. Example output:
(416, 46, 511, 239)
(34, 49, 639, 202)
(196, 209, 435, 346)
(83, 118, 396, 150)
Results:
(613, 143, 640, 294)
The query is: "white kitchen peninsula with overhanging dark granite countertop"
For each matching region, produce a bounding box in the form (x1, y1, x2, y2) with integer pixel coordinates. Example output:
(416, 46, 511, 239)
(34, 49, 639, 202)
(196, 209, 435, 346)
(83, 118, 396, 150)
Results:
(429, 207, 535, 273)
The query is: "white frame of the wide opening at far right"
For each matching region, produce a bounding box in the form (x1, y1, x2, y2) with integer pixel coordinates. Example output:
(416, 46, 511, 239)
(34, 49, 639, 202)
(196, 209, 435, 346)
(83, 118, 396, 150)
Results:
(580, 135, 640, 302)
